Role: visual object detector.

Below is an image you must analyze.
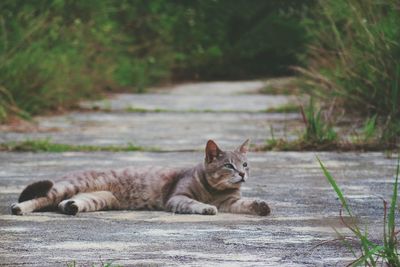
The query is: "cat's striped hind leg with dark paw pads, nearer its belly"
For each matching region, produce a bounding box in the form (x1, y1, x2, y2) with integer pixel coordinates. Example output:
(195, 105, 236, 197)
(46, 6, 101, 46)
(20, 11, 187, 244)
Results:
(58, 191, 119, 215)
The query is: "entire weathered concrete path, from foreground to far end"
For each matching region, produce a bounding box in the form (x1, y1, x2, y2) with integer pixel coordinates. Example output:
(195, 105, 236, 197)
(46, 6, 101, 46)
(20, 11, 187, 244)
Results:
(0, 78, 396, 266)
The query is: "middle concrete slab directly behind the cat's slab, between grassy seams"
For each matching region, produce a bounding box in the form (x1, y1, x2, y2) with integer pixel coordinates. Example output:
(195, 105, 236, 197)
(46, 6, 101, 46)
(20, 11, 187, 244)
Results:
(0, 112, 302, 150)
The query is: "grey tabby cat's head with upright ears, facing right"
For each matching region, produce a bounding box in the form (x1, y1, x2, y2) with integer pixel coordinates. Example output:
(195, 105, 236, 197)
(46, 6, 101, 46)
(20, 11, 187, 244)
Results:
(204, 139, 249, 190)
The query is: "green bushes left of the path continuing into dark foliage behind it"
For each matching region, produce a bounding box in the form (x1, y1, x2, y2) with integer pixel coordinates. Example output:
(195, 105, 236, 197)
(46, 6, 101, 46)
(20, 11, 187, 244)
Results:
(0, 0, 314, 121)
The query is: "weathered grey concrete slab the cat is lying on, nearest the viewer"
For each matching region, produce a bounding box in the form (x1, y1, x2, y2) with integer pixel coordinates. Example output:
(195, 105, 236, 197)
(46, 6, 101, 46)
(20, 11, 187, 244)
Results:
(0, 152, 396, 266)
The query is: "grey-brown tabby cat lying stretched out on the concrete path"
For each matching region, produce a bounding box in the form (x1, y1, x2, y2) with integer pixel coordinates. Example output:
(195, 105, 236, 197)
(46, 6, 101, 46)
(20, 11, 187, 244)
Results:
(11, 140, 271, 216)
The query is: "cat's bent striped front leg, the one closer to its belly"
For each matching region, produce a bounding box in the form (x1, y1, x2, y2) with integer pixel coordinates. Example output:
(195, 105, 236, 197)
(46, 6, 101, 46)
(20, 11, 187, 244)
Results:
(166, 195, 218, 215)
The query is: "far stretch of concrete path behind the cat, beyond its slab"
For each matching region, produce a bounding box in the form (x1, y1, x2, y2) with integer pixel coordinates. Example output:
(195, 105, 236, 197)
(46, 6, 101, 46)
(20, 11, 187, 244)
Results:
(0, 79, 302, 150)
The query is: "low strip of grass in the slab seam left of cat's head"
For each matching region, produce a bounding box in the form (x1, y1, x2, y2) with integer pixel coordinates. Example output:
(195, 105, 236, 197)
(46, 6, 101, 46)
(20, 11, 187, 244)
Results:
(0, 139, 158, 153)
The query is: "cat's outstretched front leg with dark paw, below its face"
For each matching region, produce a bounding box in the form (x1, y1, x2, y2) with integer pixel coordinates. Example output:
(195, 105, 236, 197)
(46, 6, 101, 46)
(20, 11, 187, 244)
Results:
(218, 198, 271, 216)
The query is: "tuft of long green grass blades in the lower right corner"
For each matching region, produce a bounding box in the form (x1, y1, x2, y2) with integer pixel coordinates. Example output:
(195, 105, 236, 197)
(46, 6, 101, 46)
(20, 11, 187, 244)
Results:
(317, 155, 400, 267)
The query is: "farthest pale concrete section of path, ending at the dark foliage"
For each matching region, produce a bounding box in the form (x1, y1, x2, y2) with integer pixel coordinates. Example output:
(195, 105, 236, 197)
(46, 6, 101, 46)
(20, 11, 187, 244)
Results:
(82, 78, 297, 112)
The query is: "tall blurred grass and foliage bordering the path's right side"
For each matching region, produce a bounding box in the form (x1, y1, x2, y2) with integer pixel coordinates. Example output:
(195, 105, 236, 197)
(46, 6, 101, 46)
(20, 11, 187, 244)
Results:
(303, 0, 400, 146)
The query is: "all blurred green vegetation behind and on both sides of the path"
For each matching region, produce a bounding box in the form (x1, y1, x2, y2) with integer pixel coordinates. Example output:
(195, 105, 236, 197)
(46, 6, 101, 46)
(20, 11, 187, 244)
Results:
(0, 0, 400, 144)
